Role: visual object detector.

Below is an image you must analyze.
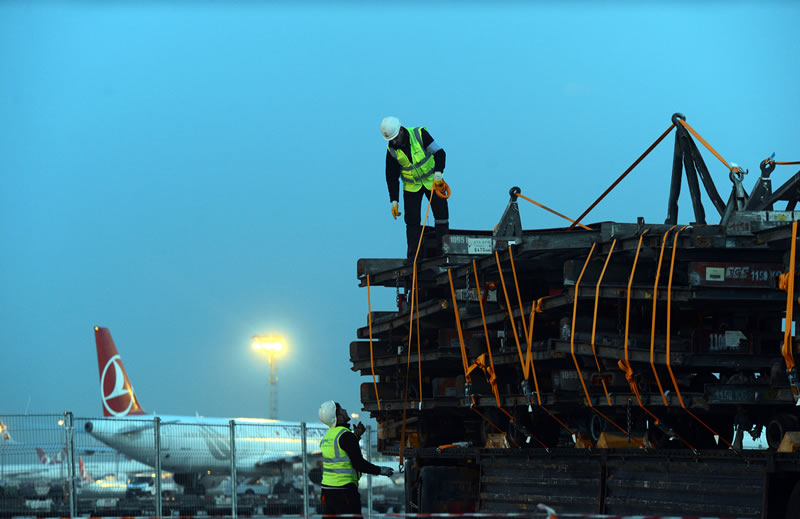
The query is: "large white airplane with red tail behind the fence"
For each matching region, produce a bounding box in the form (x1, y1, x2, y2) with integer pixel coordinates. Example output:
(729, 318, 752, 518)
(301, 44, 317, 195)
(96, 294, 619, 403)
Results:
(84, 327, 327, 492)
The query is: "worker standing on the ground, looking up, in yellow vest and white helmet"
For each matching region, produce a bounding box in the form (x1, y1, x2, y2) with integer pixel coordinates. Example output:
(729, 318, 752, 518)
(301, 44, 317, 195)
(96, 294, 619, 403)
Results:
(319, 400, 394, 515)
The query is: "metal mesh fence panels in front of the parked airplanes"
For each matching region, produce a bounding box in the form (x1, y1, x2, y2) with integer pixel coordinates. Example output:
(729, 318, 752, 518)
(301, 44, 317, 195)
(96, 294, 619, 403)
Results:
(0, 413, 405, 517)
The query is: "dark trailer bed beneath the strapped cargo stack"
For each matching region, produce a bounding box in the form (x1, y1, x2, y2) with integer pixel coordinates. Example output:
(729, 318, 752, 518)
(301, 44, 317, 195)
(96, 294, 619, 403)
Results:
(405, 448, 800, 519)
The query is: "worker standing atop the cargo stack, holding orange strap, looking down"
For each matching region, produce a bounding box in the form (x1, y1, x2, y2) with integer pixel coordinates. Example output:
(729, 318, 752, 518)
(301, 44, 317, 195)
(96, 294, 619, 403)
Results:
(381, 117, 450, 259)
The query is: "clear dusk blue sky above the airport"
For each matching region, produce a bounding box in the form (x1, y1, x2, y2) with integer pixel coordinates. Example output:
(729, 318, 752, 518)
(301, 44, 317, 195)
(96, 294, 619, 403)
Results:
(0, 1, 800, 421)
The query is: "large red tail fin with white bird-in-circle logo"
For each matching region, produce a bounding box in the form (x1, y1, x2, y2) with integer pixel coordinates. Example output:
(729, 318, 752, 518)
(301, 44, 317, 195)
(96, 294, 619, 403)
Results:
(94, 326, 145, 417)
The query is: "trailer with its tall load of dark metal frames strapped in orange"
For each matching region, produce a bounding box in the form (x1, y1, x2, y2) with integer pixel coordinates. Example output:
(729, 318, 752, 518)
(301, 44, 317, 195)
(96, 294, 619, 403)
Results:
(350, 114, 800, 519)
